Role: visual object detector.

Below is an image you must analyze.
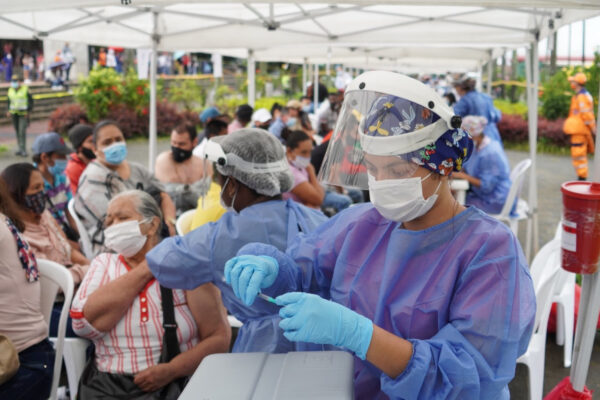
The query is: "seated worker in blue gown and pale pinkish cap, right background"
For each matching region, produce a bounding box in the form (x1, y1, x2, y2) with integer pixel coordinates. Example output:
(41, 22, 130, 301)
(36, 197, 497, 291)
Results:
(452, 115, 511, 214)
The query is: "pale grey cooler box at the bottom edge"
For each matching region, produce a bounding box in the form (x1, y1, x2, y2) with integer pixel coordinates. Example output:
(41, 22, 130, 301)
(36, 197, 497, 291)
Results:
(179, 351, 354, 400)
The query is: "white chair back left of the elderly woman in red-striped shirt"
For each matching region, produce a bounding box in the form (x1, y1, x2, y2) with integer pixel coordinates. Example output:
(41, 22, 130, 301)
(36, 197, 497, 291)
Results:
(37, 259, 74, 399)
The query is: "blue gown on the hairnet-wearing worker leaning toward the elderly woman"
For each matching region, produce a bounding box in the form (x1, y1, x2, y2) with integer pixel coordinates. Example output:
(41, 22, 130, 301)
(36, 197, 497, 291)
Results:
(146, 200, 327, 353)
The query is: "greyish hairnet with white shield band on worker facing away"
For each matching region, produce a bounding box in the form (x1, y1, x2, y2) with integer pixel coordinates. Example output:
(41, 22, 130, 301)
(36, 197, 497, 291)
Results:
(211, 128, 294, 196)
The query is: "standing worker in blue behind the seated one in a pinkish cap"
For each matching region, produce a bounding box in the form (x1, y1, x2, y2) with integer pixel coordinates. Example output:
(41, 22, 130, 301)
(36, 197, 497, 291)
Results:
(454, 78, 502, 146)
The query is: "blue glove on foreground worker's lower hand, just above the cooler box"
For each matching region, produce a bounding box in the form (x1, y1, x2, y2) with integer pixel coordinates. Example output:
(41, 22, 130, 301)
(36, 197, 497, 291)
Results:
(275, 292, 373, 360)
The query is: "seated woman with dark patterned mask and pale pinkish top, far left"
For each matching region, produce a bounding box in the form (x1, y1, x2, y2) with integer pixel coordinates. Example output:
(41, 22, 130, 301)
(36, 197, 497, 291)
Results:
(2, 163, 90, 337)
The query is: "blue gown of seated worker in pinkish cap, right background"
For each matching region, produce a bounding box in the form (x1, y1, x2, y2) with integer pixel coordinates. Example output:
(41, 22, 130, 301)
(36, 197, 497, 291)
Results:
(464, 136, 511, 214)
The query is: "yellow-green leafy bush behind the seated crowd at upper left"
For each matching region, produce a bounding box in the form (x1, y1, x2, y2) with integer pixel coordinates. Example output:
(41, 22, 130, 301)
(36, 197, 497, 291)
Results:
(75, 68, 124, 122)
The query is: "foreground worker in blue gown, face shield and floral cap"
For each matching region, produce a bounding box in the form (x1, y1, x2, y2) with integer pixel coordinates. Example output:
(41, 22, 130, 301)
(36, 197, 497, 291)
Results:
(225, 71, 536, 400)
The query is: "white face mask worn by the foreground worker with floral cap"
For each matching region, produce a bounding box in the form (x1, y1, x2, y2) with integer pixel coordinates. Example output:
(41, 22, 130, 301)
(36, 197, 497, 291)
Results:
(369, 172, 442, 222)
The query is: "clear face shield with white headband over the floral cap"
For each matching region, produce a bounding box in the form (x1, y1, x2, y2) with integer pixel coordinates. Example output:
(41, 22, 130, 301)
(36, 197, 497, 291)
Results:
(319, 71, 460, 190)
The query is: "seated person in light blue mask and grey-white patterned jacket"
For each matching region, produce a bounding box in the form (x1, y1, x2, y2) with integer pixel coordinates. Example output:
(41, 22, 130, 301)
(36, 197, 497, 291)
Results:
(75, 120, 175, 254)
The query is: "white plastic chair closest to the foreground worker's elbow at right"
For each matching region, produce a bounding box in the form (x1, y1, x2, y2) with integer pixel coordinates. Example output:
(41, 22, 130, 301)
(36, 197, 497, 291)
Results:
(517, 239, 560, 400)
